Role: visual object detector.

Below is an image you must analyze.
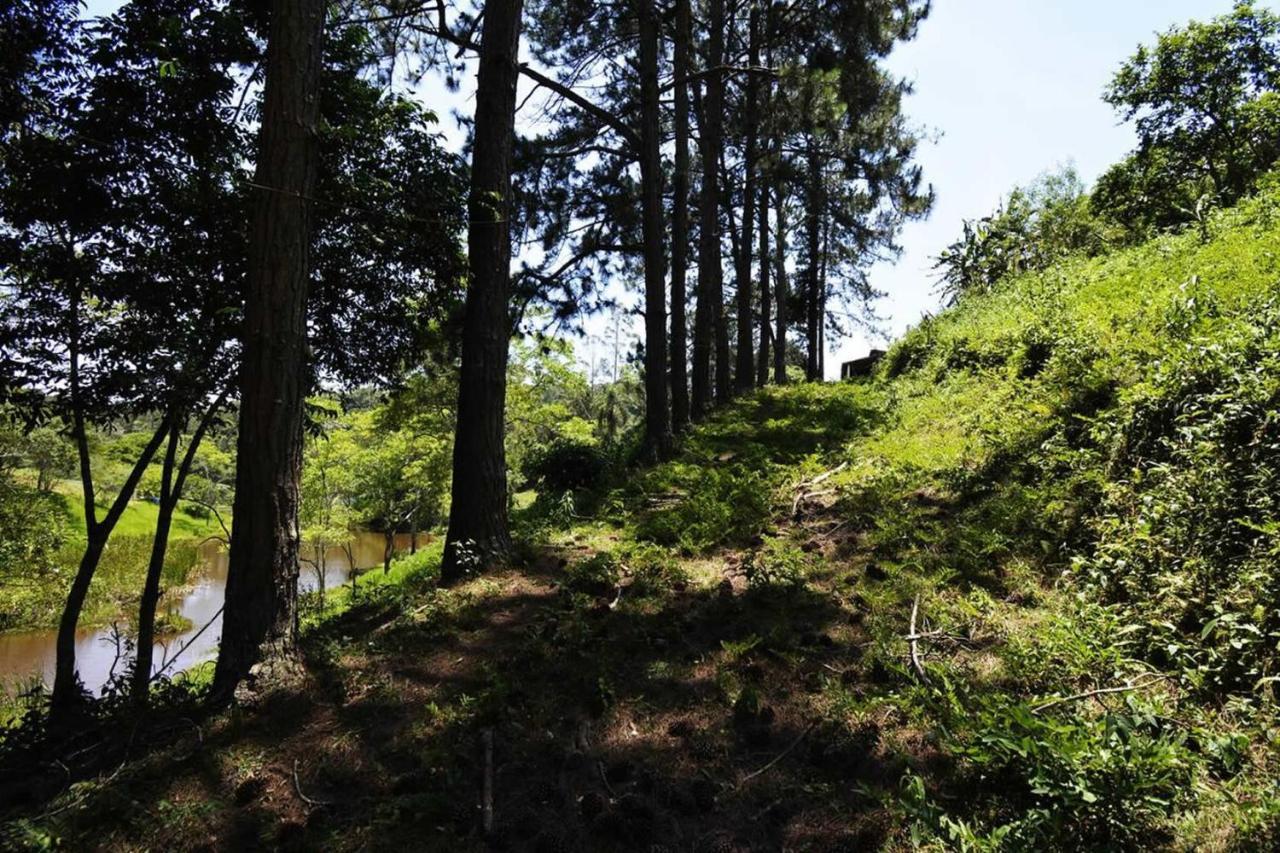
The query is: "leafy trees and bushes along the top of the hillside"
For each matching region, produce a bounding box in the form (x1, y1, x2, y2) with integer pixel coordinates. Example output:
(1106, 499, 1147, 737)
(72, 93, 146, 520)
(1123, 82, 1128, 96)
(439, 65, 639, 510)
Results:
(934, 0, 1280, 300)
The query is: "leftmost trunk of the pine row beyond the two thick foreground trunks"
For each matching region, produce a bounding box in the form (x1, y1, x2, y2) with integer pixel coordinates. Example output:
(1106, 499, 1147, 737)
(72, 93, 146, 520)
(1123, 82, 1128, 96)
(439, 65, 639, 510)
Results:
(636, 0, 671, 460)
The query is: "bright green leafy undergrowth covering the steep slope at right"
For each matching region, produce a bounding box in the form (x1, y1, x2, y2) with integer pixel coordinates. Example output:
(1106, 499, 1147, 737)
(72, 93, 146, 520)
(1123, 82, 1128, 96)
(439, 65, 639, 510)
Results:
(846, 172, 1280, 849)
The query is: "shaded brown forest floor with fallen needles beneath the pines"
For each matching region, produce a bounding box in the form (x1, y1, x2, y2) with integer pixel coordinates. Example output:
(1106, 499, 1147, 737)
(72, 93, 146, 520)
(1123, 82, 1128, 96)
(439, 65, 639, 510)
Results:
(0, 384, 983, 850)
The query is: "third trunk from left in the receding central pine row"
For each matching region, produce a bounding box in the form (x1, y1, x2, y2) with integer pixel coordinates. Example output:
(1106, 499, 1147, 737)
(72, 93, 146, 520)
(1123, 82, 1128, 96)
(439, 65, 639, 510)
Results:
(698, 0, 733, 403)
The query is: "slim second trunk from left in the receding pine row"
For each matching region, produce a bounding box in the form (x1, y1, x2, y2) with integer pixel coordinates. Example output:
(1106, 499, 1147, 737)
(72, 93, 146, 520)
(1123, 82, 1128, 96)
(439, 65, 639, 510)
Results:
(671, 0, 692, 433)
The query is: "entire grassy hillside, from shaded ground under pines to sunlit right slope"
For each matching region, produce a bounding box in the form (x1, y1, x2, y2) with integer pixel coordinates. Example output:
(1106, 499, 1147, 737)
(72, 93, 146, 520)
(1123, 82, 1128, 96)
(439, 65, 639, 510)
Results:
(8, 184, 1280, 850)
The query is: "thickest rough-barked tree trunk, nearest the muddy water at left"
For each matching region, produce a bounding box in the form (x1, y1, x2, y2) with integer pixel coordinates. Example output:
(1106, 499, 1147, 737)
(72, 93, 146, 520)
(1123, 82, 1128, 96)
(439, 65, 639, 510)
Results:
(214, 0, 326, 695)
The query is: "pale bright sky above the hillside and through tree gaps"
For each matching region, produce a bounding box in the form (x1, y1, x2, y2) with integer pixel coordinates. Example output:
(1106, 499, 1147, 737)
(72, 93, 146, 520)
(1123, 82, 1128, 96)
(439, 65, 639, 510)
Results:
(87, 0, 1274, 378)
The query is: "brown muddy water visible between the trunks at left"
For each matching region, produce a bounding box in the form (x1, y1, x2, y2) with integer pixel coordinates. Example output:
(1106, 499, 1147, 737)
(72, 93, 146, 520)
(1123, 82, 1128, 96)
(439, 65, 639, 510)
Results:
(0, 532, 430, 695)
